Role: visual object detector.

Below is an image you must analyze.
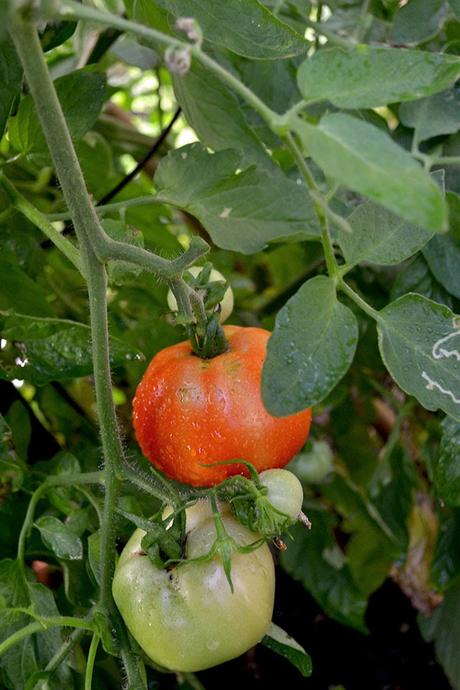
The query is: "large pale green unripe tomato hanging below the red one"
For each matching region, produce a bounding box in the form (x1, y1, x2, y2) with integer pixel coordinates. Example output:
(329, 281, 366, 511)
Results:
(112, 501, 275, 672)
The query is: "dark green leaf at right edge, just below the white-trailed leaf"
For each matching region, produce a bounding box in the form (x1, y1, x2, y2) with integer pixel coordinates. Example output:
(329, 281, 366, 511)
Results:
(433, 417, 460, 507)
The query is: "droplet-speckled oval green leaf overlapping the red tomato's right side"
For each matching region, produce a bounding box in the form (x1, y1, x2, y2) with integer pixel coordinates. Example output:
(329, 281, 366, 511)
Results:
(262, 276, 358, 416)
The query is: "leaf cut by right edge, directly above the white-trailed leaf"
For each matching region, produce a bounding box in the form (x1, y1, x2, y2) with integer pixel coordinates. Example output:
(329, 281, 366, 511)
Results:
(423, 192, 460, 298)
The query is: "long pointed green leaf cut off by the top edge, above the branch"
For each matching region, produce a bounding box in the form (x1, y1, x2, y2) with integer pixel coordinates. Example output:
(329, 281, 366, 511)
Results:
(157, 0, 309, 60)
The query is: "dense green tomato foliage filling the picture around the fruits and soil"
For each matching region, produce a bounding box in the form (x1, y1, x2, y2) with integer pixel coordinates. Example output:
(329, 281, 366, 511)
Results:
(0, 0, 460, 690)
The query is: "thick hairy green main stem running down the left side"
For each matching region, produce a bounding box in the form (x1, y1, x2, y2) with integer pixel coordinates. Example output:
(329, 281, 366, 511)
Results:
(10, 15, 142, 687)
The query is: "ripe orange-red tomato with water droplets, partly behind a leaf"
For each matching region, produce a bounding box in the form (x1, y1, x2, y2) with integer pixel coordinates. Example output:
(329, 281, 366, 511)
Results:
(133, 326, 311, 486)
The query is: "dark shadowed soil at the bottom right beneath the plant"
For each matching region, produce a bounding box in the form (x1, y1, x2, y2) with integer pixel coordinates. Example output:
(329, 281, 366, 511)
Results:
(198, 569, 451, 690)
